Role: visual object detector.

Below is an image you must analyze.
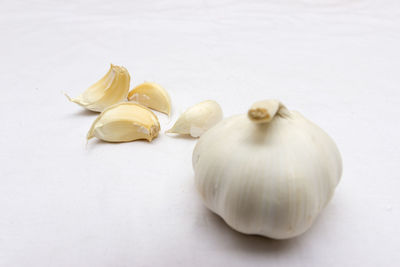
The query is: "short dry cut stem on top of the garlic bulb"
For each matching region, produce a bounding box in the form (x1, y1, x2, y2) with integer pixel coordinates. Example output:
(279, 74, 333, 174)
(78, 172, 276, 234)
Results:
(247, 99, 290, 123)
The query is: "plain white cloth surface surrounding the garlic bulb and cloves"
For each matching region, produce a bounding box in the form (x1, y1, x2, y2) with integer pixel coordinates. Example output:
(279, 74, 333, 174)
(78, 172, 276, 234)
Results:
(0, 0, 400, 267)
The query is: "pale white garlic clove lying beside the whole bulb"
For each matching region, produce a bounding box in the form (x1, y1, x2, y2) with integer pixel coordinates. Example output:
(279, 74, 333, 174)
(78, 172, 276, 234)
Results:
(166, 100, 222, 137)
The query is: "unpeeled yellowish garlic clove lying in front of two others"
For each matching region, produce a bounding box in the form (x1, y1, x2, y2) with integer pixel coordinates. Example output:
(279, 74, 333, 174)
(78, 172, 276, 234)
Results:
(87, 102, 160, 142)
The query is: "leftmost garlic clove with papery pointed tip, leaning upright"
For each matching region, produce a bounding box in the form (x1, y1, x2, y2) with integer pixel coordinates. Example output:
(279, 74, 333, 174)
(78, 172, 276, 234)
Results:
(65, 64, 130, 112)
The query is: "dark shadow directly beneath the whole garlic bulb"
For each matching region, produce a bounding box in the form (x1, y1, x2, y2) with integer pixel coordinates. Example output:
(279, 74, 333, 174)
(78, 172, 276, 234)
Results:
(204, 210, 301, 254)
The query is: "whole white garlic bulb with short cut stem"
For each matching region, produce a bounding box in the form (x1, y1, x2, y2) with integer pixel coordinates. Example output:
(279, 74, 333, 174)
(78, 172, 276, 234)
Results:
(193, 100, 342, 239)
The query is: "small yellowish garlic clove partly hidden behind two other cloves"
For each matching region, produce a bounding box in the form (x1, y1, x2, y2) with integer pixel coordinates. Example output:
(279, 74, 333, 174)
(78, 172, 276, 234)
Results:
(128, 82, 171, 116)
